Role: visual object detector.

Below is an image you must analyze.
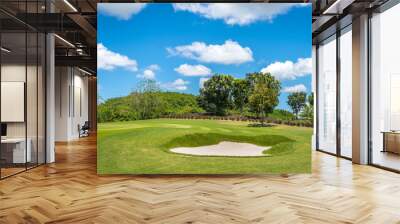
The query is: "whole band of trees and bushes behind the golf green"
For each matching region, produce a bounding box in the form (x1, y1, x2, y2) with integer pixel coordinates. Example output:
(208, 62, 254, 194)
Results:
(98, 72, 313, 124)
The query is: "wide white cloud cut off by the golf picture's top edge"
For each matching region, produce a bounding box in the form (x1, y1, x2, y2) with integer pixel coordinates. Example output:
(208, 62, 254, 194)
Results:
(173, 3, 307, 26)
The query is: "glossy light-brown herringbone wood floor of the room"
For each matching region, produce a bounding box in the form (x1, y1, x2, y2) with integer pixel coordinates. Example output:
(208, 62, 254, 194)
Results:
(0, 134, 400, 224)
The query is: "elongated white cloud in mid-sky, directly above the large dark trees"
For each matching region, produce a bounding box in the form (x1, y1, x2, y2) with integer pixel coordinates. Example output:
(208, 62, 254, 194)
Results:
(167, 40, 253, 65)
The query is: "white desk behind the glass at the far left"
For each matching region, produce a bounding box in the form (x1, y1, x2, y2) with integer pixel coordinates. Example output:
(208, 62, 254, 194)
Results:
(1, 138, 32, 163)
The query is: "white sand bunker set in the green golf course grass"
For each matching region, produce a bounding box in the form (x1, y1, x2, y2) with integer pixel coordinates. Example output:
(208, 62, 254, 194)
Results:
(170, 142, 271, 156)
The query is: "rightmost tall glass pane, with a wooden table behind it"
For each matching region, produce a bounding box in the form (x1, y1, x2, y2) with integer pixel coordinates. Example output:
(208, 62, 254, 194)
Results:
(370, 4, 400, 170)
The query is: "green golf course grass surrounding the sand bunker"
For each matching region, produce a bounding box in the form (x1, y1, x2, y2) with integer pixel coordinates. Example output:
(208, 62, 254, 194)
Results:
(97, 119, 312, 174)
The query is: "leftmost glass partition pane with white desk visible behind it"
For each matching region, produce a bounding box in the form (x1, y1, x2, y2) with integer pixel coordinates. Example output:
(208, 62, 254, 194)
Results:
(0, 32, 27, 177)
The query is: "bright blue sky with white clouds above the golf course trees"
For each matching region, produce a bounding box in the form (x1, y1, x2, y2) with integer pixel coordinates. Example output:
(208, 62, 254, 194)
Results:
(97, 3, 312, 109)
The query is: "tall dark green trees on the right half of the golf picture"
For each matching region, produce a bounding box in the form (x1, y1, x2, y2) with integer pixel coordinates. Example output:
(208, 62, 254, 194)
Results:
(199, 72, 313, 123)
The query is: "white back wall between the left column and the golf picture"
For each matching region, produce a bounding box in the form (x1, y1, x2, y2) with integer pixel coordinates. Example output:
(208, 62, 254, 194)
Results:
(55, 67, 88, 141)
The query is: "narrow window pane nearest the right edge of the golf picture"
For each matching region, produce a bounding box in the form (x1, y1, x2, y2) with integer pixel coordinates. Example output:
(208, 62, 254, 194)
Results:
(317, 35, 336, 154)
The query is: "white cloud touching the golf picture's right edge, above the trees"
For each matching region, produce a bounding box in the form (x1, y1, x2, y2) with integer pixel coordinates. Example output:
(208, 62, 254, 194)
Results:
(261, 58, 312, 80)
